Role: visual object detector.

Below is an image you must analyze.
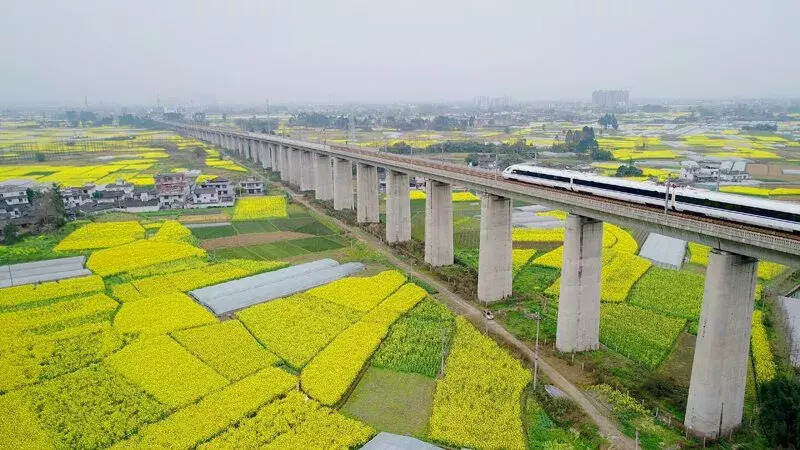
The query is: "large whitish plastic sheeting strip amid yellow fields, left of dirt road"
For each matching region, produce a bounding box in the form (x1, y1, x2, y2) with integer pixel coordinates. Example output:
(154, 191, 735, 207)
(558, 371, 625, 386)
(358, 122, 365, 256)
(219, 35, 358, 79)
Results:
(189, 259, 364, 314)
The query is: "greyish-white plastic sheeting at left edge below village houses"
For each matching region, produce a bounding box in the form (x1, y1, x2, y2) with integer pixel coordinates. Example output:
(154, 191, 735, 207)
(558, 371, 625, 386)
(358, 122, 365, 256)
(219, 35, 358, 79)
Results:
(0, 256, 92, 287)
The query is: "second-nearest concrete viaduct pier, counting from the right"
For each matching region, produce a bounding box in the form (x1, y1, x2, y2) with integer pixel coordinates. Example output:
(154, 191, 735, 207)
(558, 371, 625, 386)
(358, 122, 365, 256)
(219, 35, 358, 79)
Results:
(556, 214, 603, 352)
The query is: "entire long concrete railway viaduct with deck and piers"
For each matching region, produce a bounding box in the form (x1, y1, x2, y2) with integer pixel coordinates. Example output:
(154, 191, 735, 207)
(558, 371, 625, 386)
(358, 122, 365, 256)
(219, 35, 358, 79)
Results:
(166, 123, 800, 439)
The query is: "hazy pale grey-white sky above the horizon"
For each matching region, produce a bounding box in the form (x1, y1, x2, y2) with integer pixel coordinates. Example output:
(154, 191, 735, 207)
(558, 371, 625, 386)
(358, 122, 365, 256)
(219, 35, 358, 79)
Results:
(0, 0, 800, 107)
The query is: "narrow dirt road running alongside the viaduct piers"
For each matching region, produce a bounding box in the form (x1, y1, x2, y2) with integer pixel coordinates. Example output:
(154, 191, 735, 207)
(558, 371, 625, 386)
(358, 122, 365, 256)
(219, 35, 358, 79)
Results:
(278, 188, 636, 449)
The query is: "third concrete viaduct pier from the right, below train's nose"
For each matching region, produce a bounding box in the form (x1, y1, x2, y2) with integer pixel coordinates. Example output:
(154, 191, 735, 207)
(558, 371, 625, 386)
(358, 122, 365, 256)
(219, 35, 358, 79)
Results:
(478, 194, 511, 303)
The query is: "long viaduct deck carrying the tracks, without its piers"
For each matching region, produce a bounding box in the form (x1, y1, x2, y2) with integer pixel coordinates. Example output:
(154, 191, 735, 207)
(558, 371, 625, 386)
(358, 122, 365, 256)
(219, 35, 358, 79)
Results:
(181, 124, 800, 267)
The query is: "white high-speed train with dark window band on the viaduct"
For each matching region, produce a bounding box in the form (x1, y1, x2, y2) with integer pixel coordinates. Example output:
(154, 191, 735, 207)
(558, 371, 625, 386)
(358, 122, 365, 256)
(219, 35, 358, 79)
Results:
(503, 164, 800, 233)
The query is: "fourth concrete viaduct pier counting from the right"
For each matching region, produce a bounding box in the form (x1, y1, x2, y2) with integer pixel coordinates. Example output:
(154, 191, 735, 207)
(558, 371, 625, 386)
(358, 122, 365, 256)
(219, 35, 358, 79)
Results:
(425, 180, 453, 266)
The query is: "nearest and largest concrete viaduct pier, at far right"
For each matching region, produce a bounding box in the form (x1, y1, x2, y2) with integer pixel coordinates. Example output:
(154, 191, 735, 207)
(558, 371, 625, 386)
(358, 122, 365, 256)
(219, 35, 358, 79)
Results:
(684, 249, 758, 439)
